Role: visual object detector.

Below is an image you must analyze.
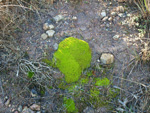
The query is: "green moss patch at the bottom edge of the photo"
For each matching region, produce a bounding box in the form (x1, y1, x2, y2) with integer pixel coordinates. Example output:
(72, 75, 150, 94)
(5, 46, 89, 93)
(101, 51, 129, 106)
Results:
(64, 97, 78, 113)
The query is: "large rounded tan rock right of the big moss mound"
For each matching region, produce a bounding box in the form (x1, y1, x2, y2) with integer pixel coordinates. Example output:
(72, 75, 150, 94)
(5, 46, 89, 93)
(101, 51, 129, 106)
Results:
(100, 53, 114, 65)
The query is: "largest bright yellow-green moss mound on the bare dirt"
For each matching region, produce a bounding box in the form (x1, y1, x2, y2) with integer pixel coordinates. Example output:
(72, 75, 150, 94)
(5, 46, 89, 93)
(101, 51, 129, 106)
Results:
(53, 37, 91, 83)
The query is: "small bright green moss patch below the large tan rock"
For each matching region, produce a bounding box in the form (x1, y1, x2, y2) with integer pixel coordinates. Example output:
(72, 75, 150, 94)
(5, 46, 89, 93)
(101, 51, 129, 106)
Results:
(95, 78, 110, 86)
